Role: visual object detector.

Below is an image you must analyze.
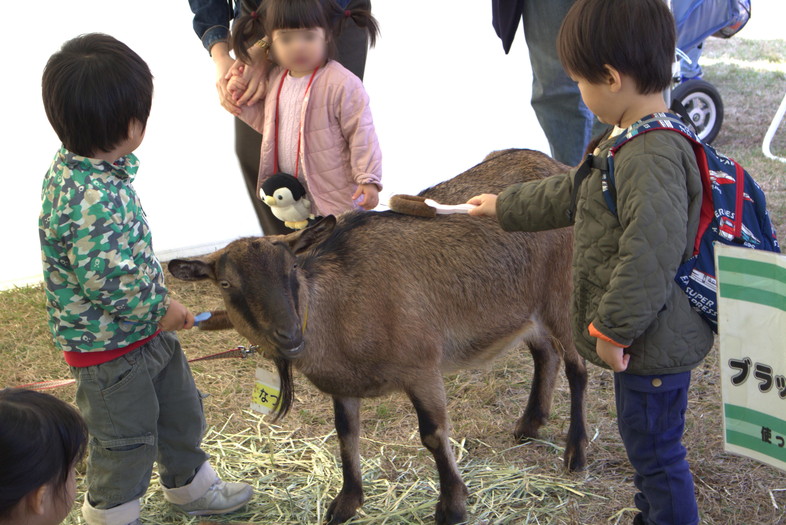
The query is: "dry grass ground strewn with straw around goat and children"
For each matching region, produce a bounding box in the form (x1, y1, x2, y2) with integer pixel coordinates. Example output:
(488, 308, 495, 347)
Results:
(0, 39, 786, 525)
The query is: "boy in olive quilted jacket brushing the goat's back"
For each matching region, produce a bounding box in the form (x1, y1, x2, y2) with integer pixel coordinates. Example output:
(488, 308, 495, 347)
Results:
(469, 0, 713, 525)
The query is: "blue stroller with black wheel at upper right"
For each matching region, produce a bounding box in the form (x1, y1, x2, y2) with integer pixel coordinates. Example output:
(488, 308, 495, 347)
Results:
(671, 0, 751, 143)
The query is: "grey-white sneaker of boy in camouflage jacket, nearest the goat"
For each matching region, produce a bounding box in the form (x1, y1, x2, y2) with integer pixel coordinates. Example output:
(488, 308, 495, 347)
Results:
(164, 461, 254, 516)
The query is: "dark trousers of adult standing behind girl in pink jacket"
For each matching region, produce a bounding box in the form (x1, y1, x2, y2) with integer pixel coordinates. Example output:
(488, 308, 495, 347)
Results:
(235, 0, 371, 235)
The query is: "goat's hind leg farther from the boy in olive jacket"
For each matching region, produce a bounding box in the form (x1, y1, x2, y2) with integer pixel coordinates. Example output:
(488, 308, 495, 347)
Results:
(513, 336, 560, 441)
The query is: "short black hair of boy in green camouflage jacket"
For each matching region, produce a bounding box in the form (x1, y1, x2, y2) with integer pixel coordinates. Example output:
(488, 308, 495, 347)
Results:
(41, 33, 153, 157)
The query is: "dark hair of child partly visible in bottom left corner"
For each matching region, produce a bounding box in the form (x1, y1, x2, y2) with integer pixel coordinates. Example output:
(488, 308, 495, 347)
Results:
(0, 388, 87, 520)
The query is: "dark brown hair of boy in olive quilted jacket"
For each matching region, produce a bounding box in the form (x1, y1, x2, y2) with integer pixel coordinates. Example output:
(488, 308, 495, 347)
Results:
(557, 0, 676, 95)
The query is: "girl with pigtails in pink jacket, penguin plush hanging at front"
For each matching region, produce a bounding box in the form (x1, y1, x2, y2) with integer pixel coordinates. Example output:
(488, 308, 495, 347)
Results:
(227, 0, 382, 229)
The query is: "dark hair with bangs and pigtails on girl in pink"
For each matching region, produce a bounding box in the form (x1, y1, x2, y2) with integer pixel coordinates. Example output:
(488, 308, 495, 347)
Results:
(232, 0, 379, 62)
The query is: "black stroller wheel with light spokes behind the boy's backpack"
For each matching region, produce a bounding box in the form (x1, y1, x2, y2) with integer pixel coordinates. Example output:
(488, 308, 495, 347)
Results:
(671, 78, 723, 143)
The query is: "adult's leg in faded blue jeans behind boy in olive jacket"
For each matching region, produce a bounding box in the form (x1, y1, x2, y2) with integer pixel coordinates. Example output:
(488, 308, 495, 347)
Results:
(523, 0, 593, 166)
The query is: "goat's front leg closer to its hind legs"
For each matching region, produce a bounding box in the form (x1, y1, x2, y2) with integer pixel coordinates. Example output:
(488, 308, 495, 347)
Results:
(407, 372, 467, 525)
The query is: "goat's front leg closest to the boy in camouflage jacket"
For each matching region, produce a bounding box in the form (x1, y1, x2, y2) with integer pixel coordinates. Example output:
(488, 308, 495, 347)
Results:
(325, 397, 363, 525)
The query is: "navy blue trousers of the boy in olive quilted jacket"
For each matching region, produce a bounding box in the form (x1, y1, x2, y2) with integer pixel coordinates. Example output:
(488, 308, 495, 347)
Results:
(614, 372, 699, 525)
